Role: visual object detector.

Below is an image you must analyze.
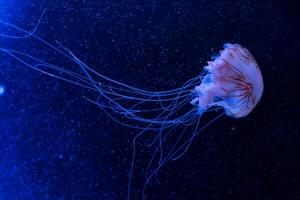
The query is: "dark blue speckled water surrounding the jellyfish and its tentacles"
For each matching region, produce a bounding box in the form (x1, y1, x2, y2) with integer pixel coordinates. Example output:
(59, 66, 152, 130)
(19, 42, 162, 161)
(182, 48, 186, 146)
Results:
(0, 0, 300, 200)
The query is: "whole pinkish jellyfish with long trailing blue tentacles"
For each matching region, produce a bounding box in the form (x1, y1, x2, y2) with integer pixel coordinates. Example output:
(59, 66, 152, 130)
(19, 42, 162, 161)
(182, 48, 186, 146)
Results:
(0, 17, 264, 199)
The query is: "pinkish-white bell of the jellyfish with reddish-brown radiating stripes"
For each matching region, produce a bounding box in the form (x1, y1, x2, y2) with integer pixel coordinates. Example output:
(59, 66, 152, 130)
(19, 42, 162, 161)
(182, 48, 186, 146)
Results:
(191, 43, 264, 118)
